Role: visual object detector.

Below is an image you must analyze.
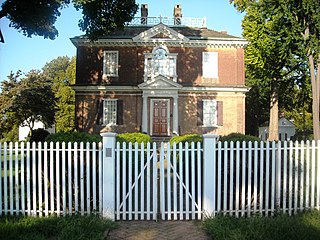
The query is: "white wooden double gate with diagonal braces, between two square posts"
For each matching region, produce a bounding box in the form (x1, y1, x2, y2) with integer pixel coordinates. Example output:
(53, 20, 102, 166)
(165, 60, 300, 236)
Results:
(115, 143, 202, 220)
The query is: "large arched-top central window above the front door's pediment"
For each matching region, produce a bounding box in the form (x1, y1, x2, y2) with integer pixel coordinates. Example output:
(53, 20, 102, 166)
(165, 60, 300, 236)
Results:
(144, 46, 177, 81)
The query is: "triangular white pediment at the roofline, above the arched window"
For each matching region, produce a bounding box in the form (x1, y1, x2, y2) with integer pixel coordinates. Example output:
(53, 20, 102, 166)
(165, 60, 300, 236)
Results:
(133, 23, 189, 42)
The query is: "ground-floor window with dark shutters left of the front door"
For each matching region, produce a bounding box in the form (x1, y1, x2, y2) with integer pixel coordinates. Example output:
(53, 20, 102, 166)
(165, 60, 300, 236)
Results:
(96, 99, 123, 126)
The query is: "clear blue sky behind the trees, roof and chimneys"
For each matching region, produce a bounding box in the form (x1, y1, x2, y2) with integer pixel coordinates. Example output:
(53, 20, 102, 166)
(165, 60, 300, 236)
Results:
(0, 0, 243, 81)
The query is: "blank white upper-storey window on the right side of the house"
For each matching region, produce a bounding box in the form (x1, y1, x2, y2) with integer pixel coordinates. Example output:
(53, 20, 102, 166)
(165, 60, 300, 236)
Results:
(202, 52, 218, 78)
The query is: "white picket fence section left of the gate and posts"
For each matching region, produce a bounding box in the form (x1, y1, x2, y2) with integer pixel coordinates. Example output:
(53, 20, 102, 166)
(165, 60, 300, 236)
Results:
(0, 142, 102, 216)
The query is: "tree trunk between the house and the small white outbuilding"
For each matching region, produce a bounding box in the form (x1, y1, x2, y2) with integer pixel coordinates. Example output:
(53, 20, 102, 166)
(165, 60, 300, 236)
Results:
(268, 87, 279, 141)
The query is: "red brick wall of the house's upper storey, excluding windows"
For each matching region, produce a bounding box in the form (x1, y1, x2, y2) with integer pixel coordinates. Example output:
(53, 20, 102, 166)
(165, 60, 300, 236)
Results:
(76, 47, 244, 86)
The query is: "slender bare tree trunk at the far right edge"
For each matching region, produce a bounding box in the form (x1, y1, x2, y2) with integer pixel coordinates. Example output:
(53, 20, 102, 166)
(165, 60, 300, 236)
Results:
(308, 53, 320, 140)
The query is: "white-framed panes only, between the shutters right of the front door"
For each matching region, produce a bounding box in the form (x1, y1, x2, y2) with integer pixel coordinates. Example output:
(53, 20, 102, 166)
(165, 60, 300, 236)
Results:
(202, 99, 218, 127)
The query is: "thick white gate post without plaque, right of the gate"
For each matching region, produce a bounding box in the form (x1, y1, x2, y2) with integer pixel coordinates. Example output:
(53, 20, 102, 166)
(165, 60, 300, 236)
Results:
(202, 134, 219, 216)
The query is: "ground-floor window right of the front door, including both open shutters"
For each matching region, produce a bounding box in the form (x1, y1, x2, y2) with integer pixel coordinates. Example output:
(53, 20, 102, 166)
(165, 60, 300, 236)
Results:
(197, 99, 223, 127)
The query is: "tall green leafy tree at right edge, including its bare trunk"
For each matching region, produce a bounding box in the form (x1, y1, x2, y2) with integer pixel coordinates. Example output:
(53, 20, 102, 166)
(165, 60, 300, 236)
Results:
(230, 0, 320, 139)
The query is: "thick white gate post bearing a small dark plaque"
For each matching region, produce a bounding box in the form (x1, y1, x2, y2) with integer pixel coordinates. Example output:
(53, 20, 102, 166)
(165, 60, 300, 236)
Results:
(100, 132, 117, 220)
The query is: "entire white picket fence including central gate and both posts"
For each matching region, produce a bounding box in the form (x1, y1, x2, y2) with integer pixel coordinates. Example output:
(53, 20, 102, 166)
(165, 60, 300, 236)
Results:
(0, 133, 320, 220)
